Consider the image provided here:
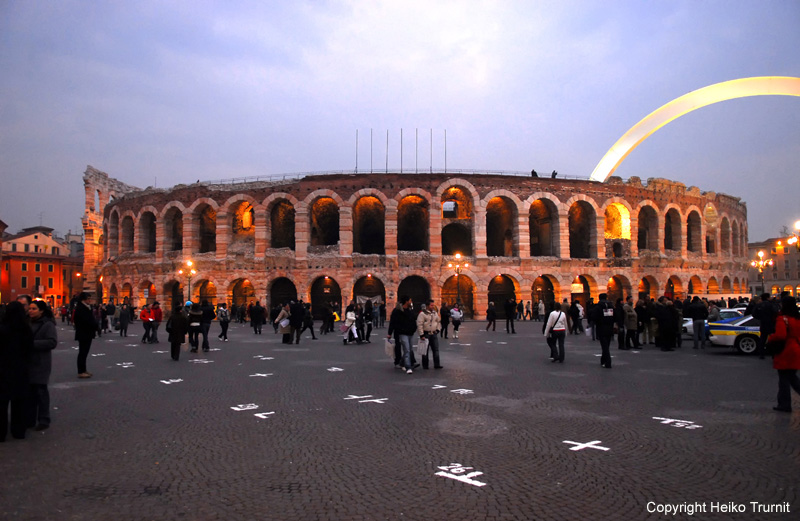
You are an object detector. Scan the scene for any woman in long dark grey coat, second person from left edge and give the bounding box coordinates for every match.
[27,300,58,431]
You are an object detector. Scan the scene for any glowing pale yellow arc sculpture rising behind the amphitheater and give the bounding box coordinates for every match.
[590,76,800,183]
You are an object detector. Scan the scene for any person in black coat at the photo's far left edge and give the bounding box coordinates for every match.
[0,302,33,442]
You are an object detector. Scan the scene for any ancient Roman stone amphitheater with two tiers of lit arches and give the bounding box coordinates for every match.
[83,166,748,317]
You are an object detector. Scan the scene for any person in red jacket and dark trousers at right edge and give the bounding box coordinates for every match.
[767,296,800,412]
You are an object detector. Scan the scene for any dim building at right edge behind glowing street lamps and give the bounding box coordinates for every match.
[747,237,800,297]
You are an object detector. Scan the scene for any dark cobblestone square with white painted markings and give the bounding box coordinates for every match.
[0,322,800,521]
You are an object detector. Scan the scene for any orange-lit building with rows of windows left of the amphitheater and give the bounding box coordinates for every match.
[0,226,83,307]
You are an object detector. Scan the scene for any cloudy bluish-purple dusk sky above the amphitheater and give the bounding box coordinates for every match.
[0,0,800,241]
